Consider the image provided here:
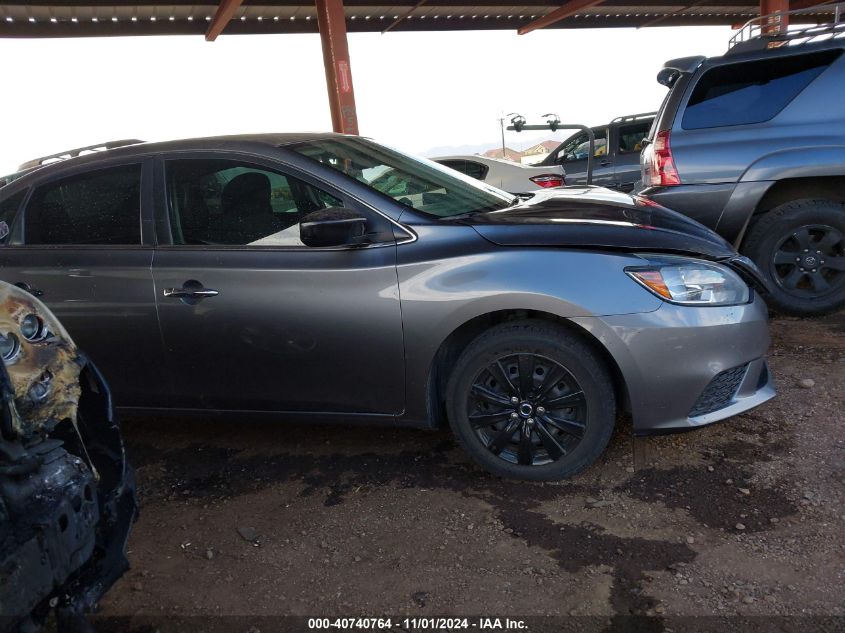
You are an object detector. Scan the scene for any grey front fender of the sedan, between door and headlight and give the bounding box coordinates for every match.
[397,227,661,423]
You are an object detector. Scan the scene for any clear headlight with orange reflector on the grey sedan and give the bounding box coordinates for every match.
[625,255,750,306]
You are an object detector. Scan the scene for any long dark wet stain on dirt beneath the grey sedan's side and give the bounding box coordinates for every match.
[136,442,695,631]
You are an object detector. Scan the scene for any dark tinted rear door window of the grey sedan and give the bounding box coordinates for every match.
[24,165,141,246]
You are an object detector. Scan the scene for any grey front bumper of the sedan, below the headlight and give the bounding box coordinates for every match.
[573,293,775,435]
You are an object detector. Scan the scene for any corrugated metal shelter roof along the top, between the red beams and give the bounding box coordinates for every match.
[0,0,833,37]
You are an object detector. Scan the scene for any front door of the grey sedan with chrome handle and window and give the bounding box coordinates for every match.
[153,153,405,416]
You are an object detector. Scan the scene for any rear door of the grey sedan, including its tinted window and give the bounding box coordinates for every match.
[0,160,167,406]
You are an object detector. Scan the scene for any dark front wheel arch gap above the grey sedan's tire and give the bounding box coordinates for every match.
[426,309,631,427]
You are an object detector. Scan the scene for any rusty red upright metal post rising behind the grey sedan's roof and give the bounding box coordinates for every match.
[316,0,358,134]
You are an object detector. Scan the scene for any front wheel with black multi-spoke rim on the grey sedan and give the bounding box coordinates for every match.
[446,321,616,481]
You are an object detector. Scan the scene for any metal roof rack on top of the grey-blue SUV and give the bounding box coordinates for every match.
[726,2,845,55]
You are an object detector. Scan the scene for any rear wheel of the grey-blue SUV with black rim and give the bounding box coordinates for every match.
[742,200,845,316]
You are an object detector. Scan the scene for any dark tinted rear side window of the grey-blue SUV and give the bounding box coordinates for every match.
[681,50,842,130]
